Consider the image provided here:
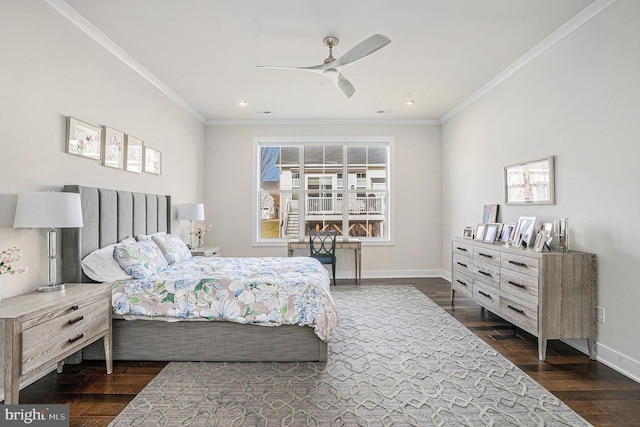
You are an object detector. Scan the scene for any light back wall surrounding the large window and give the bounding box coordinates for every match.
[205,125,442,278]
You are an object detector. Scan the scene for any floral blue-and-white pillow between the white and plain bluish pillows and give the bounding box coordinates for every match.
[113,240,169,279]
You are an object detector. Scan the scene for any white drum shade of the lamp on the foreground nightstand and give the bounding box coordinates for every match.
[13,191,83,228]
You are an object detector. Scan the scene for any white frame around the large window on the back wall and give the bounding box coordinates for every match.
[251,136,395,246]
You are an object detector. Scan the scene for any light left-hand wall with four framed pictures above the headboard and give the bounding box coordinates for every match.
[0,0,205,298]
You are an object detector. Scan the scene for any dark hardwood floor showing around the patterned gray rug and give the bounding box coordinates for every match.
[10,279,640,426]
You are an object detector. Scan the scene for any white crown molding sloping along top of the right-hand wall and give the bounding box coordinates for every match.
[440,0,617,123]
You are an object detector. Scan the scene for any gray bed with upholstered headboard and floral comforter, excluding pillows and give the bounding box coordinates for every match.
[62,185,338,362]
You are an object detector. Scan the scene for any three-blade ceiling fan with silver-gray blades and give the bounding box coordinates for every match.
[257,34,391,98]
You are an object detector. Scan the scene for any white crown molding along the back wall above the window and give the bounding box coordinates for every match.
[206,119,440,126]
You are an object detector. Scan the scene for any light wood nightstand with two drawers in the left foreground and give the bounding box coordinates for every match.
[0,283,113,405]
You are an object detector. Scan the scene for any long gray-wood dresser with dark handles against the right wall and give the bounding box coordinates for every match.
[451,238,596,360]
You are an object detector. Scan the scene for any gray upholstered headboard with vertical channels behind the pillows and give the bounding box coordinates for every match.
[62,185,171,283]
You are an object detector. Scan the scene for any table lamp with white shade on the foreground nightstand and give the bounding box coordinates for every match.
[13,191,83,292]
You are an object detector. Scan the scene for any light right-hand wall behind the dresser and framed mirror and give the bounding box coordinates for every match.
[442,0,640,378]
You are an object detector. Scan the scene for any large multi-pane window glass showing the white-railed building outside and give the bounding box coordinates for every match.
[255,139,390,244]
